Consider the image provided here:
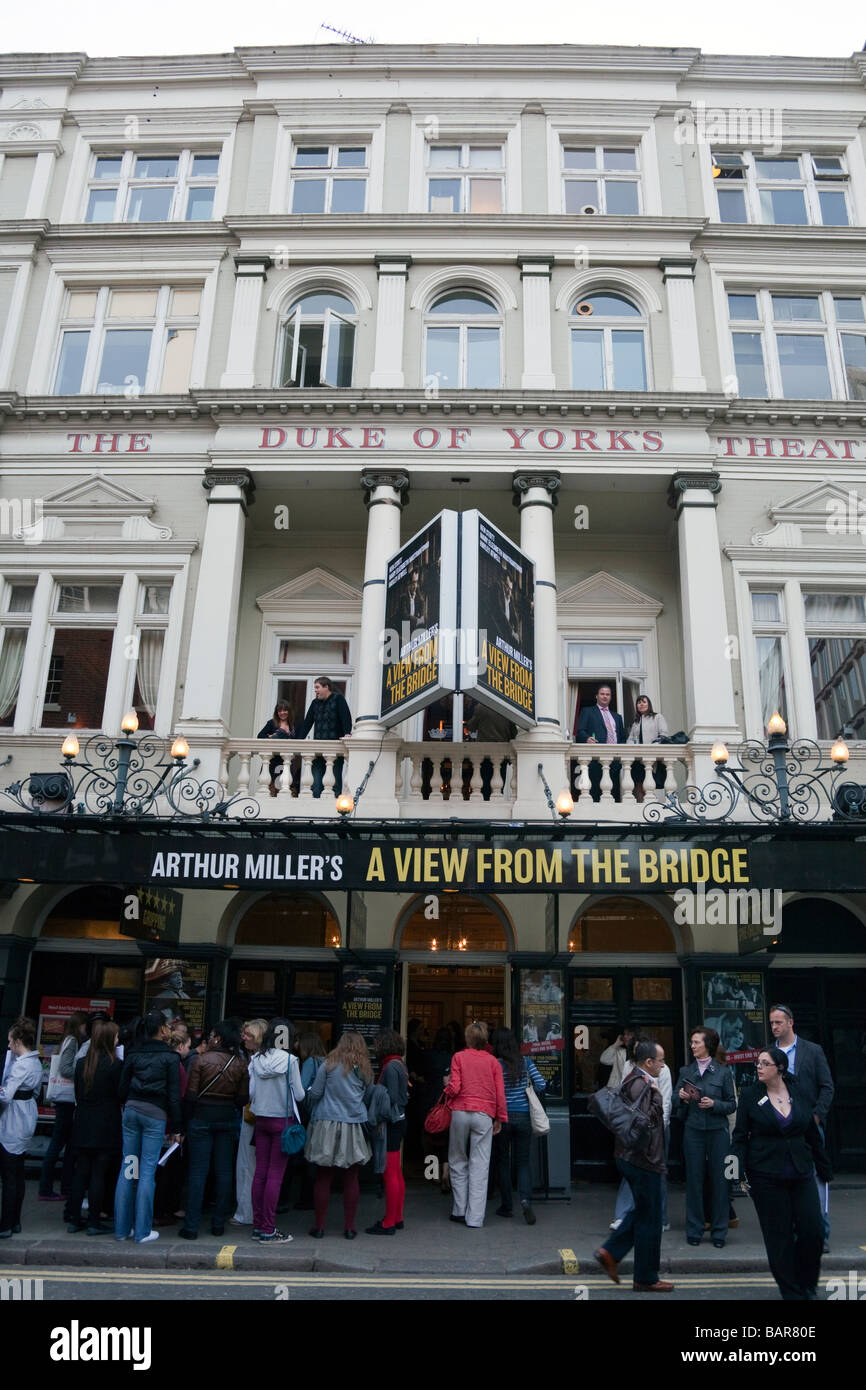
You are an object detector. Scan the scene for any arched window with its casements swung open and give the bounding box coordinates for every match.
[279,291,357,386]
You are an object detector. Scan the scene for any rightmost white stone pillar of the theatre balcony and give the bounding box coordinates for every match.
[669,473,740,742]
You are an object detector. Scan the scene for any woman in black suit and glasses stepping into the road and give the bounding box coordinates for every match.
[734,1047,831,1302]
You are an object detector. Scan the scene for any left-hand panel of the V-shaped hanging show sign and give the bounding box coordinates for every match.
[379,512,457,727]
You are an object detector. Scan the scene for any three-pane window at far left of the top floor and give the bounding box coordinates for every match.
[85,150,220,222]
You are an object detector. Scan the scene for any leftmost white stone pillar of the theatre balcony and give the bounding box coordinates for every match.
[178,468,254,774]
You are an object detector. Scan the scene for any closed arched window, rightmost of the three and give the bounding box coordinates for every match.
[570,291,646,391]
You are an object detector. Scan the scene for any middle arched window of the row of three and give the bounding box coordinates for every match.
[424,289,502,391]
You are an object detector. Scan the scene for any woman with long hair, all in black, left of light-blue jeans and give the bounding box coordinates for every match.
[67,1019,122,1236]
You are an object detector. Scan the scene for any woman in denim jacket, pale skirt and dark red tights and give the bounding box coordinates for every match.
[304,1033,373,1240]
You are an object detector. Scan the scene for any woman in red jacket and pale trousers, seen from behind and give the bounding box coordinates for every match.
[445,1023,509,1227]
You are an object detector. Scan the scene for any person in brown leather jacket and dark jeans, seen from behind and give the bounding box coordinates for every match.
[178,1019,249,1240]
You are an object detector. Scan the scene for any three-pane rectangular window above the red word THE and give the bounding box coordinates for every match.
[53,285,202,396]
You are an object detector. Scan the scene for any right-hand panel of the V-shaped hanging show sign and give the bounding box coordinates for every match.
[460,512,535,728]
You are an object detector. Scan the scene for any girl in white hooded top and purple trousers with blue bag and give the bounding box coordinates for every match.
[249,1019,304,1245]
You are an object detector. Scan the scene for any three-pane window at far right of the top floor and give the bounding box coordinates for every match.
[712,150,851,227]
